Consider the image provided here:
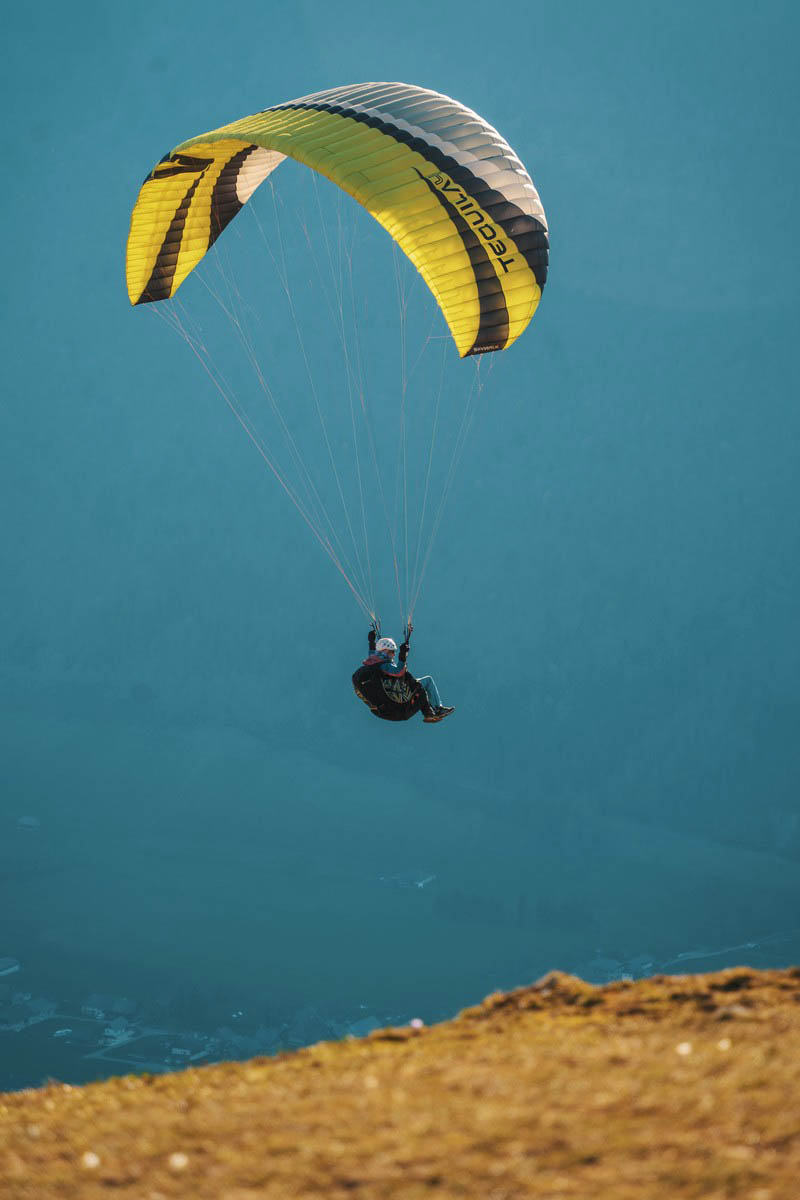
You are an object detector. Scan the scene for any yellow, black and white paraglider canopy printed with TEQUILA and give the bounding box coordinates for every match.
[127,83,548,356]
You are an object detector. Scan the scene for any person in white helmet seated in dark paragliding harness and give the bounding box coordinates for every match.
[353,620,455,725]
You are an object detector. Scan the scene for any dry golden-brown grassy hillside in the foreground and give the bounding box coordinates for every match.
[0,968,800,1200]
